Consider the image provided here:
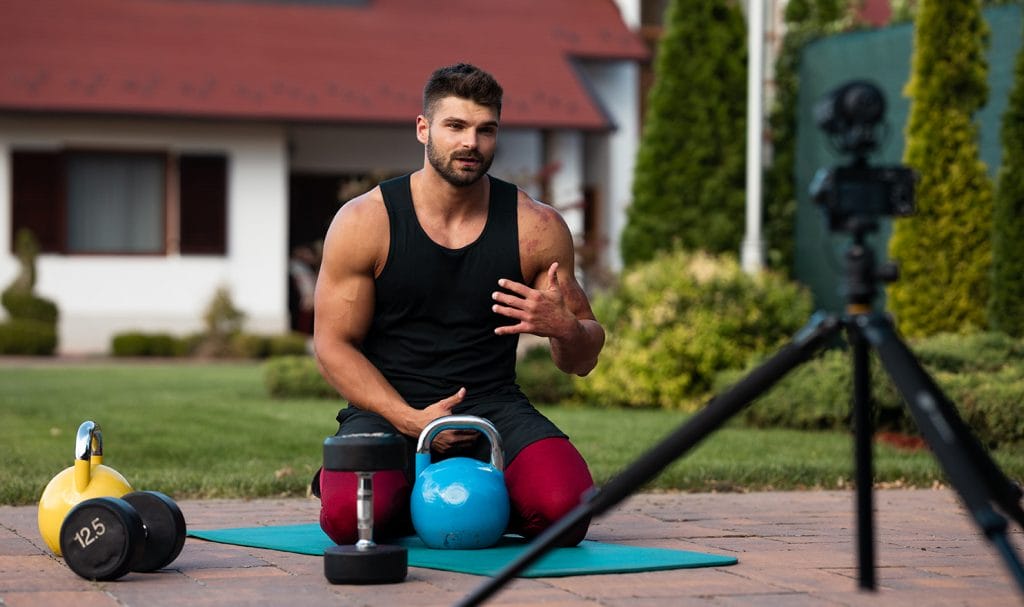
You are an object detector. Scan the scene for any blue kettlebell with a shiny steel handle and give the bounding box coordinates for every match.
[411,416,509,550]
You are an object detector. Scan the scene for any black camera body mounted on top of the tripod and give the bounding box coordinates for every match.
[810,165,915,231]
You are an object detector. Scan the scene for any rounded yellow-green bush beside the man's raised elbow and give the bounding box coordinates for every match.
[574,252,811,410]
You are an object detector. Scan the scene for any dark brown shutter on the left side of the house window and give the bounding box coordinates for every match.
[10,150,66,253]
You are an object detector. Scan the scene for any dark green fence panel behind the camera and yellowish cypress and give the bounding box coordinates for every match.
[794,5,1022,312]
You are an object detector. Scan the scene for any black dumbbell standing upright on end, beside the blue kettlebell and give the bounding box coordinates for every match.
[324,434,409,583]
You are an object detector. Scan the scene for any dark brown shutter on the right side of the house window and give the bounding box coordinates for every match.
[178,155,227,255]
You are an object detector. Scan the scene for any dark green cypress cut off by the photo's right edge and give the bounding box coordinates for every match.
[988,18,1024,337]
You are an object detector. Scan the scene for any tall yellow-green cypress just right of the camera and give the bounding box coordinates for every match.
[888,0,992,337]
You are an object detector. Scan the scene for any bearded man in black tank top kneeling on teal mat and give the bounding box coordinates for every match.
[313,63,604,545]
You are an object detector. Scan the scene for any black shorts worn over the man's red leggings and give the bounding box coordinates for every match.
[312,386,568,494]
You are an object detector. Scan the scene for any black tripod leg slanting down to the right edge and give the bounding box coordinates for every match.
[862,316,1024,592]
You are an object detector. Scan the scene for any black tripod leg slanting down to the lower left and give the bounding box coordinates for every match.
[458,314,842,606]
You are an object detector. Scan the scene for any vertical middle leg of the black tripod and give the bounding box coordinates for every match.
[849,316,876,591]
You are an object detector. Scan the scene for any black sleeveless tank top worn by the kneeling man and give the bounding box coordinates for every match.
[362,175,523,408]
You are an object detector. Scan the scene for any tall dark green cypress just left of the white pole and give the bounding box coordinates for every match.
[622,0,746,265]
